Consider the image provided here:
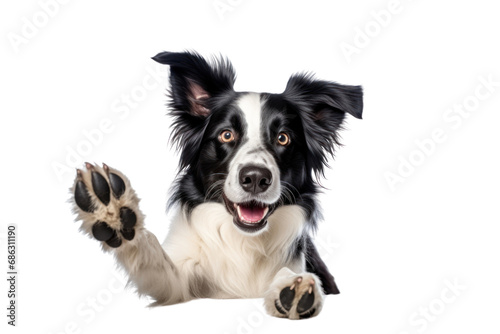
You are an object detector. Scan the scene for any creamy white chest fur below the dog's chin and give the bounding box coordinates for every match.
[163,203,305,298]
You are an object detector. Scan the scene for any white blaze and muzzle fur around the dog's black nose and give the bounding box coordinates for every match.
[224,93,280,204]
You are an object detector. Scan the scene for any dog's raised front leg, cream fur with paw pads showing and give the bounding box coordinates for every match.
[72,163,189,305]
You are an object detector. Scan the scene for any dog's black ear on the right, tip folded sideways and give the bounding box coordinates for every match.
[283,74,363,176]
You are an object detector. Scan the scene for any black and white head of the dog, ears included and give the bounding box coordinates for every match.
[153,52,363,233]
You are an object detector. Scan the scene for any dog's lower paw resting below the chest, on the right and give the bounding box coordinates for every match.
[264,268,324,319]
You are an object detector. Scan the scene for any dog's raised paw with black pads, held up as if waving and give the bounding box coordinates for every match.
[72,163,144,248]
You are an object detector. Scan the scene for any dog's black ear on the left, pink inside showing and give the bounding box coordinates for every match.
[153,52,235,117]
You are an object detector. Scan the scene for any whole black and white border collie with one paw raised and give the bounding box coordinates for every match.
[72,52,363,319]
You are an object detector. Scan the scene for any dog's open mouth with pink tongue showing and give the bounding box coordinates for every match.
[224,195,274,233]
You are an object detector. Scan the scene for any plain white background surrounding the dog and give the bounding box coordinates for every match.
[0,0,500,334]
